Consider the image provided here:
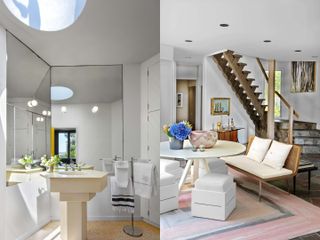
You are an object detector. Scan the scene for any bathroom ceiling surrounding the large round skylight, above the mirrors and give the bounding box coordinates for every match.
[0,0,160,65]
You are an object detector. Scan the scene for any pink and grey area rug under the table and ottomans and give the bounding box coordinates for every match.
[160,171,320,240]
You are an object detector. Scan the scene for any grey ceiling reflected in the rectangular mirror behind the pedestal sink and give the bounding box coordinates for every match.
[51,65,122,104]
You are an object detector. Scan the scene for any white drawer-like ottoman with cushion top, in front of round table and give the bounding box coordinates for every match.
[191,173,236,220]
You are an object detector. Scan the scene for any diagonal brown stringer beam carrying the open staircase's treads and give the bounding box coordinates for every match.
[223,51,264,117]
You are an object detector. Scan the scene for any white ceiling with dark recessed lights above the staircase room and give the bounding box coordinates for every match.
[160,0,320,62]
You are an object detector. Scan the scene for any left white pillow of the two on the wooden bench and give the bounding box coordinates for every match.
[247,137,272,162]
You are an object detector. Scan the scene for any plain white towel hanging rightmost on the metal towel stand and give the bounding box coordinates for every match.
[133,162,158,199]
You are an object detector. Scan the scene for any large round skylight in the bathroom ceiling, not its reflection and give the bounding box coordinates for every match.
[3,0,86,31]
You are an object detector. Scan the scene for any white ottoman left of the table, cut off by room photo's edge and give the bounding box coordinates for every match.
[160,159,183,213]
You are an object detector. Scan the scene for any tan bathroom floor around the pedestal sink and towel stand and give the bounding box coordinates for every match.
[28,221,160,240]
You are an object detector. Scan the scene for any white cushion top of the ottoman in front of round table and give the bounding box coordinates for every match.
[194,173,233,192]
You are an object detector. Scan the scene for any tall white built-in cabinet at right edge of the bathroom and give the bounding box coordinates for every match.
[141,55,160,225]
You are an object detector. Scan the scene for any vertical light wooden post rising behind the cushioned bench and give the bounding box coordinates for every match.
[267,60,276,139]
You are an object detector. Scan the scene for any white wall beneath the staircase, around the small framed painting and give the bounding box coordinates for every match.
[202,57,255,143]
